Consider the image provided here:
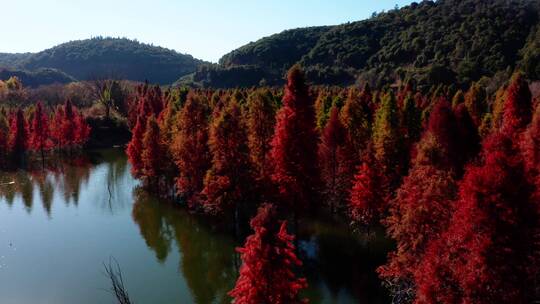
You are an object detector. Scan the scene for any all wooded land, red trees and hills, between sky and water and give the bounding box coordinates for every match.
[0,0,540,304]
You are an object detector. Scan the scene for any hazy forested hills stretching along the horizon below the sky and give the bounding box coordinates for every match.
[0,0,540,88]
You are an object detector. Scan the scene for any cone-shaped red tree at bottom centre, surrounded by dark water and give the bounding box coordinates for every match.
[229,204,307,304]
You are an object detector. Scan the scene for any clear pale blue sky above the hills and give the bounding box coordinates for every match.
[0,0,412,62]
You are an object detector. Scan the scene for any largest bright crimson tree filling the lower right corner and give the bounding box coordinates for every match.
[415,132,539,304]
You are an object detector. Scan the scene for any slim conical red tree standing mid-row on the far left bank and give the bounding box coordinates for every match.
[29,102,52,163]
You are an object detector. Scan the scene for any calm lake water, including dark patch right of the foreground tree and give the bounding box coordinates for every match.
[0,150,388,304]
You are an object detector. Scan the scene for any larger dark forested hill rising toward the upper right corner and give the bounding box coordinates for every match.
[187,0,540,87]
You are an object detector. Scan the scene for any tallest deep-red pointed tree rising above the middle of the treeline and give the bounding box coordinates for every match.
[270,66,319,215]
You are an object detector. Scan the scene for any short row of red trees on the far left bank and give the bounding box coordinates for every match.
[0,99,90,169]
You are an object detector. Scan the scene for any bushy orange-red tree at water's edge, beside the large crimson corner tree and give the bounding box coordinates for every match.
[379,164,457,283]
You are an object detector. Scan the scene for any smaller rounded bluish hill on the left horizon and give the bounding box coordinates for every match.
[0,37,204,84]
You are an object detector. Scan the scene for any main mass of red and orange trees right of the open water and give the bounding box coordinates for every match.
[127,67,540,303]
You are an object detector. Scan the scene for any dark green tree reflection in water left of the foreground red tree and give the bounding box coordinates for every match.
[133,189,238,304]
